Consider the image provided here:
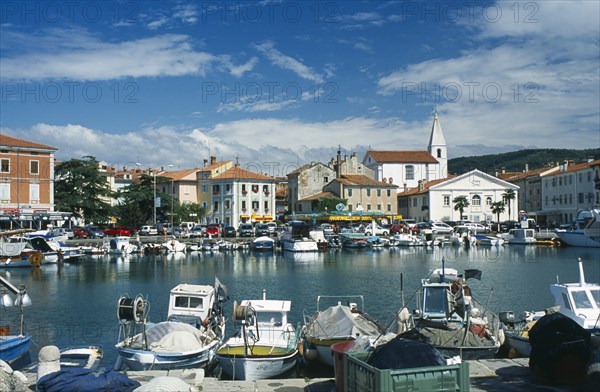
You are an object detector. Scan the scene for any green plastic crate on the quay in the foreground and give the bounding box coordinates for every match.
[344,352,471,392]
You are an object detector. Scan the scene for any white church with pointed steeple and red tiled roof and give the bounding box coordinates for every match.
[363,113,448,192]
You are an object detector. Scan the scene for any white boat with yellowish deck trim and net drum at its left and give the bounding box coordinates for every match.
[216,290,298,380]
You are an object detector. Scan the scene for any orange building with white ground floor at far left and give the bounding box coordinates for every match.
[0,134,58,226]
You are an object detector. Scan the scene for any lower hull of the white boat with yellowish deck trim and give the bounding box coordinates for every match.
[217,350,298,381]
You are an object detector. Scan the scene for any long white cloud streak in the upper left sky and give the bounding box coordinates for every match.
[0,31,217,80]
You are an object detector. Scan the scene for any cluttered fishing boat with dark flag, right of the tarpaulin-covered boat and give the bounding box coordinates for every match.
[412,267,504,360]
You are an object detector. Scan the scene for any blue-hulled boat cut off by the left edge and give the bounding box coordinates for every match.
[0,276,31,365]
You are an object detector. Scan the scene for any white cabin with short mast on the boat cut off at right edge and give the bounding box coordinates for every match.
[550,262,600,331]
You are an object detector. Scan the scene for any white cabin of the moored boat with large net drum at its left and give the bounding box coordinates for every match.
[168,283,216,324]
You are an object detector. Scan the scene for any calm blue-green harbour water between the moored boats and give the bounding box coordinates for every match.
[0,245,600,372]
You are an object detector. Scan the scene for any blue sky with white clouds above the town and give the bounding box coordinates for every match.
[0,0,600,175]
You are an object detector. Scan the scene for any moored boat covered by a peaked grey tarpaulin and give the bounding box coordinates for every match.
[302,295,385,366]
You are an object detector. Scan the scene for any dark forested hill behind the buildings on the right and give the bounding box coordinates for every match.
[448,148,600,175]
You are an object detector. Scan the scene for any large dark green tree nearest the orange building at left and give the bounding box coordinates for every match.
[54,156,113,223]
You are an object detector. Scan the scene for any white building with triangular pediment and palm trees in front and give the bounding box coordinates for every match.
[398,170,519,222]
